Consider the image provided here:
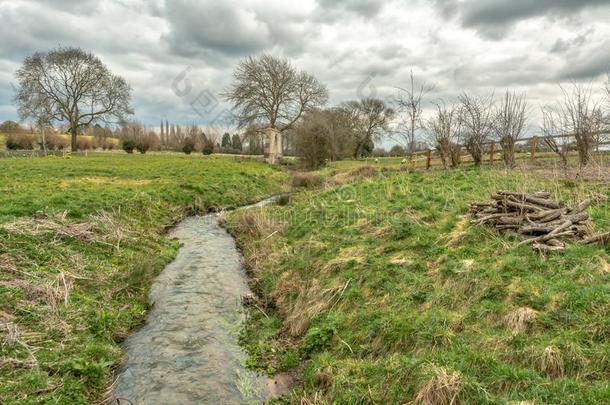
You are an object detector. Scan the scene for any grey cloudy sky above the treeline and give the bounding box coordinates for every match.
[0,0,610,133]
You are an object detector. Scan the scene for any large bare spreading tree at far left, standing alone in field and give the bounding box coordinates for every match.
[15,47,132,150]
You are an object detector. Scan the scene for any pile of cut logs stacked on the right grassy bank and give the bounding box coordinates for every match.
[470,190,610,252]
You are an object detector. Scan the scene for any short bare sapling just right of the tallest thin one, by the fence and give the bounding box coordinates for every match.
[426,102,460,169]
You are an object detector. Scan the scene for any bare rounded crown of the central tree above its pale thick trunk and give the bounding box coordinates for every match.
[224,55,328,132]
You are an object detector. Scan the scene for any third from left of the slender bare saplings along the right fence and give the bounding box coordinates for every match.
[459,93,494,166]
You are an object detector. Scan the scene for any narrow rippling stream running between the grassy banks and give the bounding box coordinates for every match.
[113,199,274,404]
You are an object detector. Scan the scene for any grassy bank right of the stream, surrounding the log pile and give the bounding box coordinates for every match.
[227,169,610,404]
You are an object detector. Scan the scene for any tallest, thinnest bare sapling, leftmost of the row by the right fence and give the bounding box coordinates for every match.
[395,71,432,159]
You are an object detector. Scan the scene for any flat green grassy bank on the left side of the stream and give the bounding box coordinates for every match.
[0,155,285,403]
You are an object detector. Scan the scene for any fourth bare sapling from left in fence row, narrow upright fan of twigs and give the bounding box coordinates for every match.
[492,91,528,167]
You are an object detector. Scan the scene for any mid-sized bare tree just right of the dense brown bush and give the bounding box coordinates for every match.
[339,98,394,159]
